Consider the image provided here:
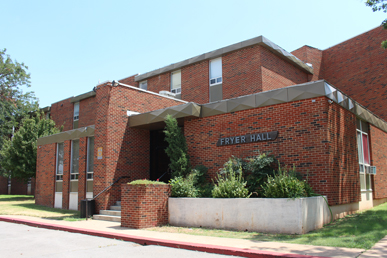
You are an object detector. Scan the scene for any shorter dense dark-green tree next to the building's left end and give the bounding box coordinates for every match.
[0,113,59,181]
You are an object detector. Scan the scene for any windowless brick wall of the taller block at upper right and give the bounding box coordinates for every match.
[321,27,387,120]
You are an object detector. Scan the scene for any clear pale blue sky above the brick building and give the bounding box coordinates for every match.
[0,0,386,107]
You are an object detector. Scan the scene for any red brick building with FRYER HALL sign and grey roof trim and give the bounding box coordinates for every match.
[36,27,387,218]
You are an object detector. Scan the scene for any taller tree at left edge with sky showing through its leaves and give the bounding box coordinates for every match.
[0,49,38,175]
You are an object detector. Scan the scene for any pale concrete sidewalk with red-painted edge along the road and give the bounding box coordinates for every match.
[0,215,376,258]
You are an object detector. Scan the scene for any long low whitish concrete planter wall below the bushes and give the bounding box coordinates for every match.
[168,196,330,234]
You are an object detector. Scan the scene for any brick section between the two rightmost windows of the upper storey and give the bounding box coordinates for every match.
[181,60,210,104]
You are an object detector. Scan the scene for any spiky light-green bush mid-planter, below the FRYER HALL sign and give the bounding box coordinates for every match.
[212,159,251,198]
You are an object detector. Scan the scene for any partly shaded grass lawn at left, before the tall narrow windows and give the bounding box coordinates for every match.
[0,195,82,221]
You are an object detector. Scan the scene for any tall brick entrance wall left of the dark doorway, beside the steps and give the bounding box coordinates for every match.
[94,84,182,211]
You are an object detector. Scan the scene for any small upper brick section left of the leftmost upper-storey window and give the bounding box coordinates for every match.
[50,98,74,131]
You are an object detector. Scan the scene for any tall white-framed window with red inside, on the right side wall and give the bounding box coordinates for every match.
[356,120,372,190]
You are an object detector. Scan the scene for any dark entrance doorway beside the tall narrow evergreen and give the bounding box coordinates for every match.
[150,130,171,183]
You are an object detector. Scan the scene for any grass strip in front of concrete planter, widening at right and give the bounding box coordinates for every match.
[148,203,387,249]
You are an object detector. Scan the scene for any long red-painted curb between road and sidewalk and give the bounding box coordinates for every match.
[0,217,328,258]
